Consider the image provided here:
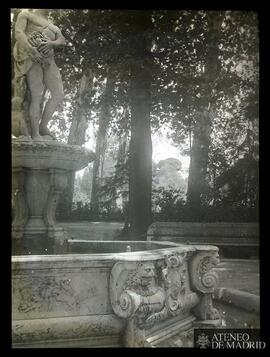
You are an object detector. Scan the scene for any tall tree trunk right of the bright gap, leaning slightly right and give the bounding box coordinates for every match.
[187,12,223,210]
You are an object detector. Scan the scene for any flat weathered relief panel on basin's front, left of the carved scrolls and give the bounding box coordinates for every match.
[12,256,115,320]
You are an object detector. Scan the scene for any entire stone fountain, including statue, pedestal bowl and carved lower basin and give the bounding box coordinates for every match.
[12,9,220,348]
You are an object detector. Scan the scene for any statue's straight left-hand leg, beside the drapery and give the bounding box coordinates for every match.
[26,63,44,140]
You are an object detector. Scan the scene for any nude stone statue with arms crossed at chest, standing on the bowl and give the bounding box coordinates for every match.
[13,9,66,140]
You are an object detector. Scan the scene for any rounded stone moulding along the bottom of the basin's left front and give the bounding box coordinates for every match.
[12,314,124,347]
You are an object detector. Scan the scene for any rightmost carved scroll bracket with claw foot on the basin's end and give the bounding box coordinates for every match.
[189,247,221,326]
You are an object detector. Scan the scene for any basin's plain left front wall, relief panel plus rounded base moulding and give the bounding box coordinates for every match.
[12,256,123,347]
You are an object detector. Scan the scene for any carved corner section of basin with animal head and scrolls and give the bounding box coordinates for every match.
[110,242,220,347]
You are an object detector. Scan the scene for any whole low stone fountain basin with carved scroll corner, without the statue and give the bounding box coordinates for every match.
[12,241,220,348]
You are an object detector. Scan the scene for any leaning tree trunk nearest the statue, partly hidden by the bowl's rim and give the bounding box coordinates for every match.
[58,69,94,217]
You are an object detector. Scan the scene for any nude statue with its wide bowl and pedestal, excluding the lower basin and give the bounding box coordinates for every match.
[12,9,94,254]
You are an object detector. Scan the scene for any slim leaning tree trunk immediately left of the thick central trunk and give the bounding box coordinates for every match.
[91,71,114,218]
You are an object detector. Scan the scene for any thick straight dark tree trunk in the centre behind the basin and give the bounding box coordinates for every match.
[129,11,152,240]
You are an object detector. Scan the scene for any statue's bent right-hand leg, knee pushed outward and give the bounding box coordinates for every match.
[39,61,64,136]
